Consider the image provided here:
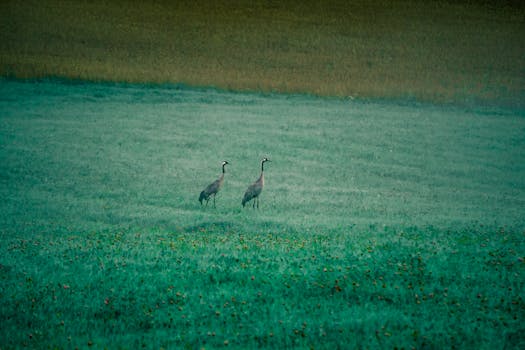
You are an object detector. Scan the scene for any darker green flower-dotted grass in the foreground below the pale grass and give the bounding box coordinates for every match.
[1,226,525,349]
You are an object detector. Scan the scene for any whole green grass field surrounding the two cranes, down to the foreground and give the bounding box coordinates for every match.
[0,80,525,349]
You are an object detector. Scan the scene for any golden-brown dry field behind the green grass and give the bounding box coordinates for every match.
[0,0,525,106]
